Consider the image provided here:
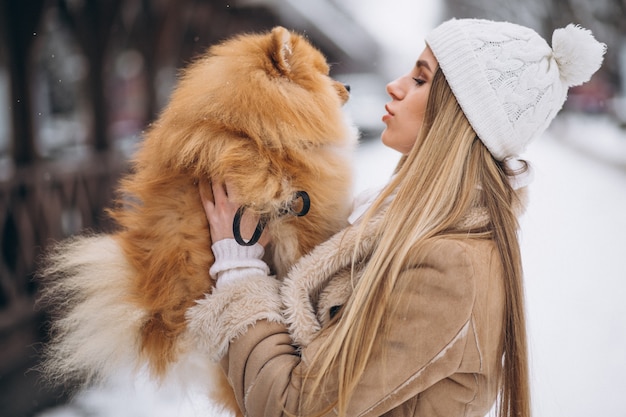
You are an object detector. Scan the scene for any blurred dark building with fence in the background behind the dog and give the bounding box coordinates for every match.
[0,0,380,417]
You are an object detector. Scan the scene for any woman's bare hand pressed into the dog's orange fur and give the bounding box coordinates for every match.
[199,182,270,247]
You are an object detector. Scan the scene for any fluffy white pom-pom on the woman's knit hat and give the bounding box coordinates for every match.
[552,23,606,87]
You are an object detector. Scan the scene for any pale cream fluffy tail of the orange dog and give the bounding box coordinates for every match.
[38,235,147,385]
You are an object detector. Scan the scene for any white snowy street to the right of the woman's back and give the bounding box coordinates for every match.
[521,119,626,417]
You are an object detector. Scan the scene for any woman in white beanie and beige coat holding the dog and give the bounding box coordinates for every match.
[188,19,605,417]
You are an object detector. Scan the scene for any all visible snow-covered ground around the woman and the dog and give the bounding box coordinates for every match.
[39,115,626,417]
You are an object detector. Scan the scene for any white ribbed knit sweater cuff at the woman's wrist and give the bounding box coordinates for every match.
[209,239,270,288]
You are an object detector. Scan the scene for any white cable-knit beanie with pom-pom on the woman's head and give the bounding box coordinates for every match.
[426,19,606,161]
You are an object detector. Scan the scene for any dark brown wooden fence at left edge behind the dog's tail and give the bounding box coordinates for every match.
[0,153,127,416]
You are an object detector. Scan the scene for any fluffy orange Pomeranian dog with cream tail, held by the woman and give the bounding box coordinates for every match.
[40,27,357,410]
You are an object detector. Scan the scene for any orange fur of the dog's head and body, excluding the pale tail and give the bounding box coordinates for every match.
[105,27,355,412]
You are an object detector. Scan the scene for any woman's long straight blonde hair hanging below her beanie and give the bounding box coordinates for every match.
[301,70,530,417]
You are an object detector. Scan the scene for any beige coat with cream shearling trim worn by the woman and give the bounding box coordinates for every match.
[188,206,504,417]
